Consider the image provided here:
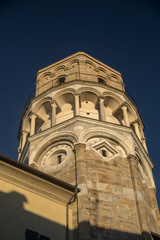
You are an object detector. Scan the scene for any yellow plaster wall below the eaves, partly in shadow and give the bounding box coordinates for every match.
[0,175,72,240]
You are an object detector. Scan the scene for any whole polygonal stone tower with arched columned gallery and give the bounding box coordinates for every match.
[18,52,160,240]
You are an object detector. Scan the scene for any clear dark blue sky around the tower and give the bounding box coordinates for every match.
[0,0,160,205]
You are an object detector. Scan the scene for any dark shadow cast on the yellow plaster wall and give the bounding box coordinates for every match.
[0,192,70,240]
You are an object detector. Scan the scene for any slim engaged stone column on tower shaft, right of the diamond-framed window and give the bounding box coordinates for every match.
[128,154,151,240]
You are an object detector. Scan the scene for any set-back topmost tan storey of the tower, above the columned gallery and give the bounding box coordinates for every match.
[36,52,124,96]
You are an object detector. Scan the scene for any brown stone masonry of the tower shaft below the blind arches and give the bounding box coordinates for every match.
[48,144,158,240]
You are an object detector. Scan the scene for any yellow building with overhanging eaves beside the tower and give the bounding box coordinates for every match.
[0,155,77,240]
